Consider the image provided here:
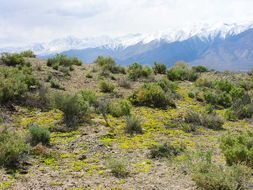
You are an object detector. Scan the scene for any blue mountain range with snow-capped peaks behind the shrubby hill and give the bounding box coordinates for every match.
[0,23,253,71]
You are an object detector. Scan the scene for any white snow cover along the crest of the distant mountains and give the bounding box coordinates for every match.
[0,22,253,55]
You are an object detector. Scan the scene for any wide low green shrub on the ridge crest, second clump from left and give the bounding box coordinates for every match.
[47,54,82,70]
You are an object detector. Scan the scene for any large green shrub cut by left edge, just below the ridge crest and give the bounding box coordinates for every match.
[0,67,39,104]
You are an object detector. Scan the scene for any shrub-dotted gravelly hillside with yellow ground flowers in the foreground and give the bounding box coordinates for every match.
[0,52,253,190]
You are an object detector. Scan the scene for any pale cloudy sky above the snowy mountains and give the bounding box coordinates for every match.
[0,0,253,47]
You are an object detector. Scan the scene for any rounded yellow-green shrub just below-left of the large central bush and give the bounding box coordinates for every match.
[109,100,131,117]
